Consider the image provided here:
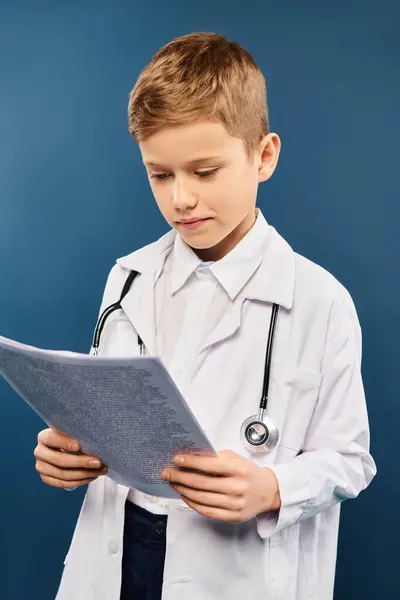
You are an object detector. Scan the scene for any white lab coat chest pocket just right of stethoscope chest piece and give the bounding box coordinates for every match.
[268,363,322,460]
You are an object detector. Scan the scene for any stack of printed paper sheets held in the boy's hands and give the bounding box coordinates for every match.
[0,336,216,498]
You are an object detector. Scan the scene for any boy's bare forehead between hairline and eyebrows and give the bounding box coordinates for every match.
[139,122,242,167]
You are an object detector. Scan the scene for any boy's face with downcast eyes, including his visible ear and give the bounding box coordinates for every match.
[139,121,280,261]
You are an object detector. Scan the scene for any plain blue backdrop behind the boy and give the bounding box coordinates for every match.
[0,0,400,600]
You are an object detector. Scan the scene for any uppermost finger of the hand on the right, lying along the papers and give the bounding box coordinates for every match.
[174,454,247,476]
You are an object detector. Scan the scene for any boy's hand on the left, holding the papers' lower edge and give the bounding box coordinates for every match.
[34,429,108,489]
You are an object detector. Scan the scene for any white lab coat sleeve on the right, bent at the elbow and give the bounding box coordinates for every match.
[256,286,376,539]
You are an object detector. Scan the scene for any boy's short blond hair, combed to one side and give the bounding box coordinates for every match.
[128,33,269,158]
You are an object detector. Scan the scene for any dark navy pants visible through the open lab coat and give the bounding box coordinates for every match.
[120,500,167,600]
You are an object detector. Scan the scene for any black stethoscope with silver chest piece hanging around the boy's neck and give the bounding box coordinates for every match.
[92,271,279,454]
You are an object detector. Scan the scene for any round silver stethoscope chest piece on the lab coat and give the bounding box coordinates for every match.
[240,415,279,454]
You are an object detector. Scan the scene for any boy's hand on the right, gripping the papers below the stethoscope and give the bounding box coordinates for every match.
[162,450,281,523]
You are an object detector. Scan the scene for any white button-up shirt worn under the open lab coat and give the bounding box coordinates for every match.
[128,208,268,514]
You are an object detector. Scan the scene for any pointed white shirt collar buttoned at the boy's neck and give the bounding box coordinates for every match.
[171,208,269,301]
